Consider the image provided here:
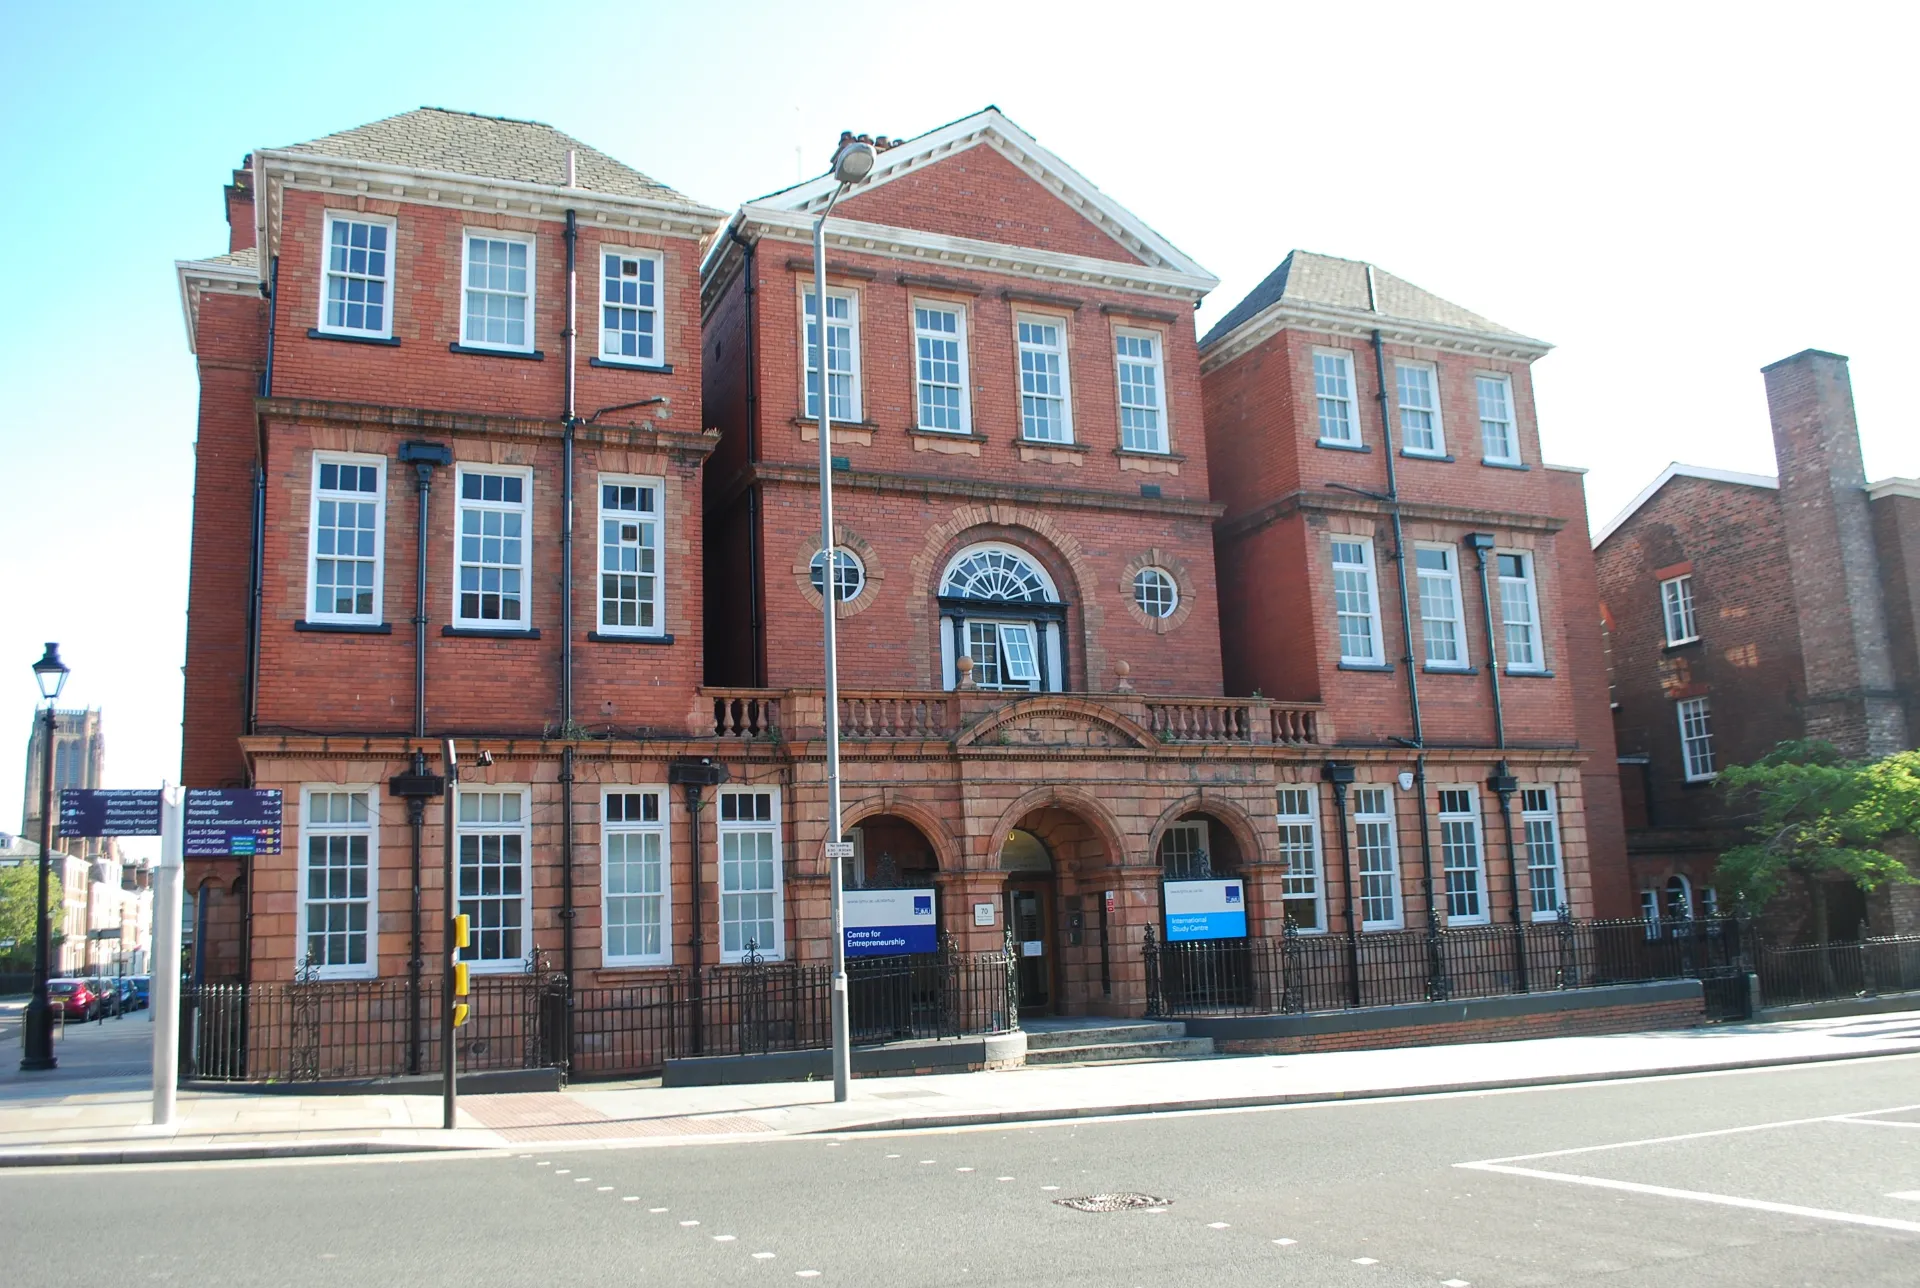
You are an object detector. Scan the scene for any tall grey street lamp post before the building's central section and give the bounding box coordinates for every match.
[814,134,876,1102]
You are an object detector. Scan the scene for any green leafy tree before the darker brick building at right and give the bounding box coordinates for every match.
[1718,739,1920,944]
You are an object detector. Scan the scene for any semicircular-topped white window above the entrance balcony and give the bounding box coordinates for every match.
[939,541,1068,693]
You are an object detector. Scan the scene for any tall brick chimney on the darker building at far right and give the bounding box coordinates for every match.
[1761,349,1907,756]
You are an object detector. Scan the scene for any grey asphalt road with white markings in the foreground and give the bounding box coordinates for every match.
[0,1058,1920,1288]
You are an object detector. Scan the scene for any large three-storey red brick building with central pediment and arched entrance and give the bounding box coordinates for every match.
[180,109,1617,1044]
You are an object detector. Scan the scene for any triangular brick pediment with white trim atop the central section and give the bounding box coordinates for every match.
[753,107,1215,284]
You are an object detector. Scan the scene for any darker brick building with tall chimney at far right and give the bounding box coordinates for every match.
[1596,349,1920,939]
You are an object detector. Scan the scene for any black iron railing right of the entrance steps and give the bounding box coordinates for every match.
[1144,918,1745,1015]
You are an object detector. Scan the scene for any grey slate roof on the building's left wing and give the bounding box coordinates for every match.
[280,107,697,205]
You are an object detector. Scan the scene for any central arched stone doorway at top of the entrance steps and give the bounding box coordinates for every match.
[998,802,1117,1015]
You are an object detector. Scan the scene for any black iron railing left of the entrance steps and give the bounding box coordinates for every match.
[180,944,1020,1083]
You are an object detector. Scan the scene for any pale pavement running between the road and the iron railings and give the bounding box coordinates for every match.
[11,1012,1920,1165]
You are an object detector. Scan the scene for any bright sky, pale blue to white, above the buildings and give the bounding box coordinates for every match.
[0,0,1920,856]
